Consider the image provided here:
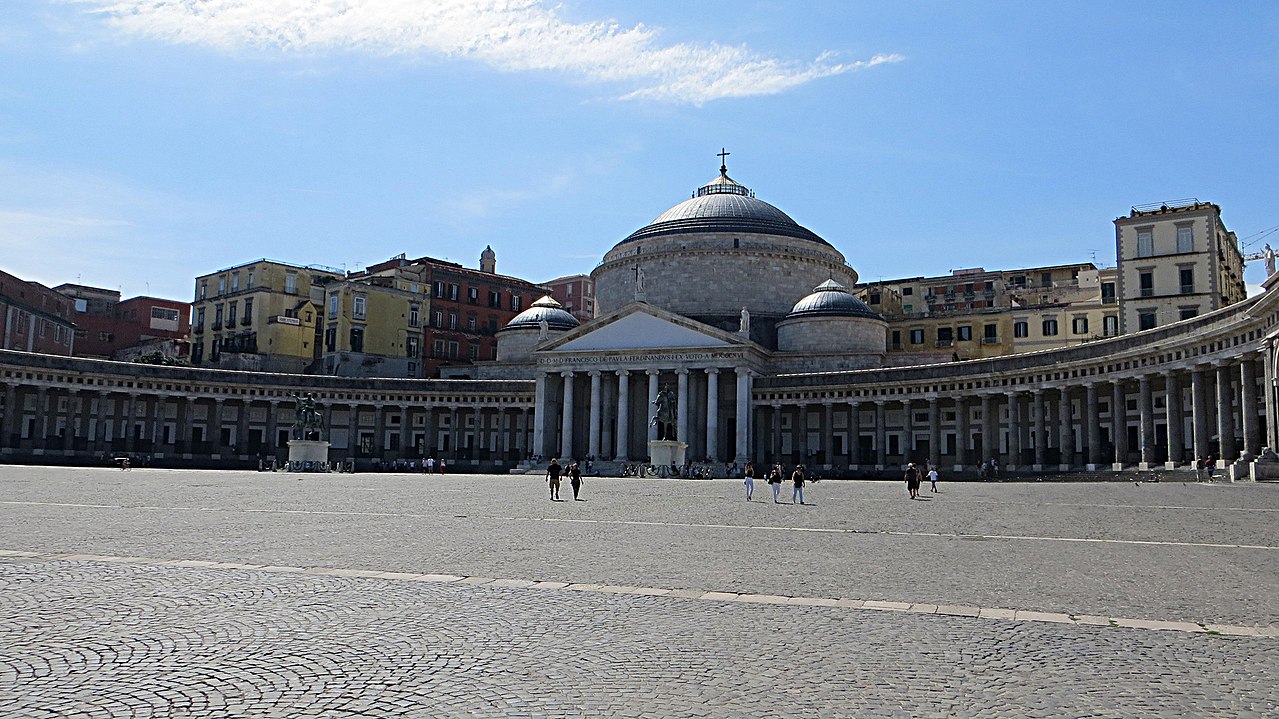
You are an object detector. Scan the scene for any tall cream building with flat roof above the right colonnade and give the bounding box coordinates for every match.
[1115,200,1247,333]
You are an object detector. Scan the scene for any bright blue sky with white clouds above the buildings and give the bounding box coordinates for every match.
[0,0,1279,301]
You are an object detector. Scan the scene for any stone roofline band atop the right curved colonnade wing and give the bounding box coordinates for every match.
[755,293,1279,391]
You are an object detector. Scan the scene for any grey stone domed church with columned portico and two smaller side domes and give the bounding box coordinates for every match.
[473,152,885,462]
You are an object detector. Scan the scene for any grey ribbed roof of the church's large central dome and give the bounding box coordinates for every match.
[618,166,828,246]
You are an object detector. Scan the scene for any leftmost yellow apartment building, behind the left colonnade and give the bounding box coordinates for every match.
[191,260,343,372]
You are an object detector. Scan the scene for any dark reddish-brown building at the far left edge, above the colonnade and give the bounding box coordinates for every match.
[0,271,75,354]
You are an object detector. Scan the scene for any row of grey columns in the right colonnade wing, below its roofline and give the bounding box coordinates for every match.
[756,352,1275,470]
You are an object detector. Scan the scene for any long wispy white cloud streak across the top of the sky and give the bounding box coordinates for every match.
[70,0,902,104]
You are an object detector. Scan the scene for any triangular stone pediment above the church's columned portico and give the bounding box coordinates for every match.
[544,306,746,352]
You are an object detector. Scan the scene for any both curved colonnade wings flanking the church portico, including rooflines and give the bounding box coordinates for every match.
[0,278,1279,471]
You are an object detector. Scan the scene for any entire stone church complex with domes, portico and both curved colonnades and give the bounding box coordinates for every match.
[0,166,1279,471]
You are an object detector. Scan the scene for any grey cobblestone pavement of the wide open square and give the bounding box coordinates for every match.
[0,467,1279,718]
